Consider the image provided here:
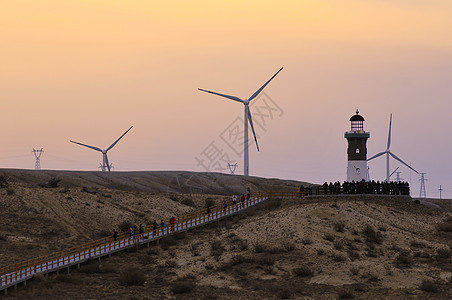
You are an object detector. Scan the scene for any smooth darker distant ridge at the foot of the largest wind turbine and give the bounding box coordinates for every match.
[0,169,306,195]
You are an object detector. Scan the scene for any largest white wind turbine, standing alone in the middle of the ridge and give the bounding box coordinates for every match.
[198,68,283,176]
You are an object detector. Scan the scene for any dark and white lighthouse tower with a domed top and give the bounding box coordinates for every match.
[345,110,370,181]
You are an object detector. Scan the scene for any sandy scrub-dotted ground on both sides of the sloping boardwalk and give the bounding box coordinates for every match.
[0,170,452,299]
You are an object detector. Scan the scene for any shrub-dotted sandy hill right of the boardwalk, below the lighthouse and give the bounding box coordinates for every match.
[5,196,452,299]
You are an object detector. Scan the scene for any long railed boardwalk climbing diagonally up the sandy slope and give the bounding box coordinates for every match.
[0,192,297,294]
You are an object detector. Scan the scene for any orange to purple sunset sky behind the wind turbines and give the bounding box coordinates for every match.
[0,0,452,198]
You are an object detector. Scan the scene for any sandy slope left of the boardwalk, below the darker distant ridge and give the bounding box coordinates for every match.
[0,183,231,266]
